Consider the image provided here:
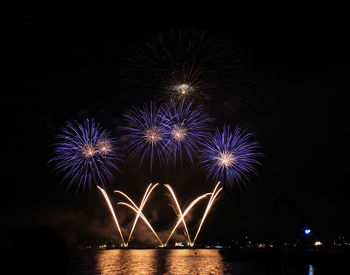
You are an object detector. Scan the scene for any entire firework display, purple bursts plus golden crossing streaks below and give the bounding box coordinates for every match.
[50,30,262,247]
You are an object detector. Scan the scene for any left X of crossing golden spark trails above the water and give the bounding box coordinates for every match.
[114,183,163,245]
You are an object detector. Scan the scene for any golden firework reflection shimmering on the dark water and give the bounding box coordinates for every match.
[96,249,224,275]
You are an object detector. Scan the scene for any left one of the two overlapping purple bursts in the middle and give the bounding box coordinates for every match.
[123,102,167,170]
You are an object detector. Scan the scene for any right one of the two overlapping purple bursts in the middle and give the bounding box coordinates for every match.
[164,100,209,164]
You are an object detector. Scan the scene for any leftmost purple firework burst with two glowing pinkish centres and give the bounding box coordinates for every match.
[50,119,119,191]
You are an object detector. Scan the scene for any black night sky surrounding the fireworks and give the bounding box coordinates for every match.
[1,10,350,248]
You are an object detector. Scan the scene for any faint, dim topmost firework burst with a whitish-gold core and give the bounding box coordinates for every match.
[122,29,249,104]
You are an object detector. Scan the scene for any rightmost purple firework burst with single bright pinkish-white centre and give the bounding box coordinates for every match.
[200,126,262,189]
